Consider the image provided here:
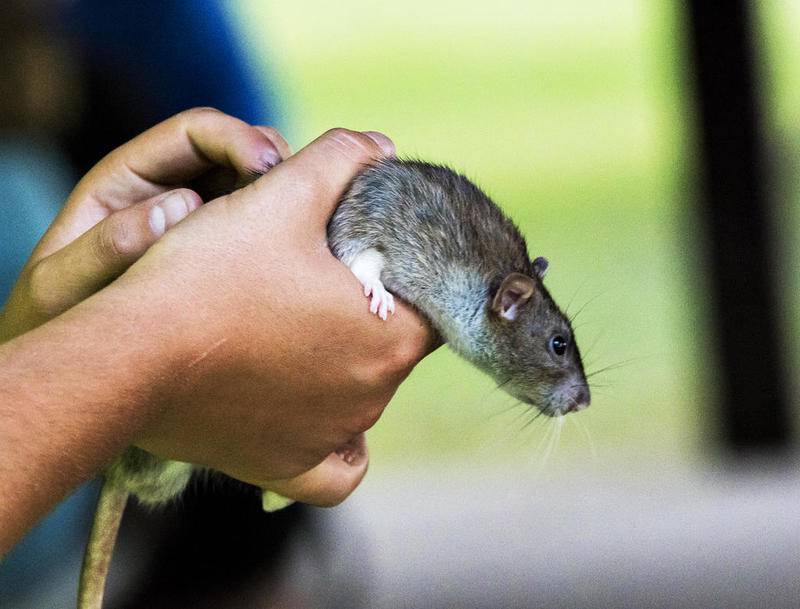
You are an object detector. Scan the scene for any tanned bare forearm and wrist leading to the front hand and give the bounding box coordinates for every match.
[0,291,173,556]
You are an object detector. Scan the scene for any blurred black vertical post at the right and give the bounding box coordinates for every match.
[689,0,791,452]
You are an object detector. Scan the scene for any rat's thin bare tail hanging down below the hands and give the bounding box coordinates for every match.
[78,479,129,609]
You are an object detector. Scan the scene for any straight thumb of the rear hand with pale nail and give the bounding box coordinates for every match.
[30,189,202,317]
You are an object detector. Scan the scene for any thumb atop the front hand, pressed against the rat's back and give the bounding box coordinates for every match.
[244,129,394,224]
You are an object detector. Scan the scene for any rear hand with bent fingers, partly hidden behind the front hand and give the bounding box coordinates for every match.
[0,108,290,342]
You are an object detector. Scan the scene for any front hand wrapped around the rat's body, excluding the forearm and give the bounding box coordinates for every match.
[94,129,433,496]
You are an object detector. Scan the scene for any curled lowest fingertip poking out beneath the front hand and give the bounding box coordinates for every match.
[263,434,369,507]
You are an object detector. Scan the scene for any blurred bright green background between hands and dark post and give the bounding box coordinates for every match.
[231,0,707,467]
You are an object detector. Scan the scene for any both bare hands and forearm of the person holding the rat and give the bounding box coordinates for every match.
[0,110,432,552]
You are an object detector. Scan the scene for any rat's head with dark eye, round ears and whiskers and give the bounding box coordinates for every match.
[487,258,591,416]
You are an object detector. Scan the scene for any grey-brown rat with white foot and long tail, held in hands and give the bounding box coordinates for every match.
[78,159,591,609]
